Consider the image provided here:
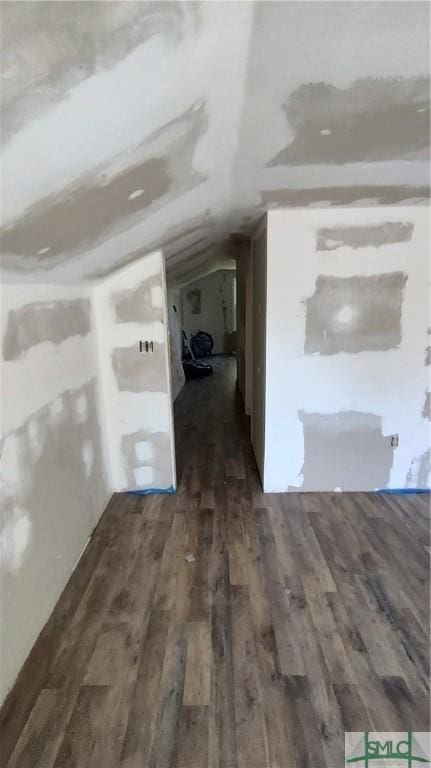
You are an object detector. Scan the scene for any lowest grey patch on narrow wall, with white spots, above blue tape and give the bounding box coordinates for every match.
[121,431,172,488]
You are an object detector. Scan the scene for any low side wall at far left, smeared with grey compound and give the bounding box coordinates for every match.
[0,285,111,699]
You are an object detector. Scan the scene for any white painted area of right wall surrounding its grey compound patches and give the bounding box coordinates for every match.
[265,206,430,491]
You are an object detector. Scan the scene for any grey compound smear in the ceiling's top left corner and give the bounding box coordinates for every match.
[1,0,201,141]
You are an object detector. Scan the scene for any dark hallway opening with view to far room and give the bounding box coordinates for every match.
[167,259,241,494]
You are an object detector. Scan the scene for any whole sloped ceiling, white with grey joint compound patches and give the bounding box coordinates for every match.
[1,0,429,282]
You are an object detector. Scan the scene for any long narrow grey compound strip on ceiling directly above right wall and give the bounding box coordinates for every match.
[259,185,430,208]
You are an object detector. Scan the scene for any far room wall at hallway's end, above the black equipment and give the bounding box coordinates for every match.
[181,269,236,354]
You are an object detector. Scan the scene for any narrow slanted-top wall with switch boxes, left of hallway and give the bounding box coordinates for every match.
[94,252,175,491]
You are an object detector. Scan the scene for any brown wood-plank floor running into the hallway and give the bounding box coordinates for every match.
[2,359,429,768]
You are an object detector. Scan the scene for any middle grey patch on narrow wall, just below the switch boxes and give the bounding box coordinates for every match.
[111,348,167,392]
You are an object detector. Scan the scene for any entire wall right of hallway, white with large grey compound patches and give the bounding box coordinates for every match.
[264,207,430,491]
